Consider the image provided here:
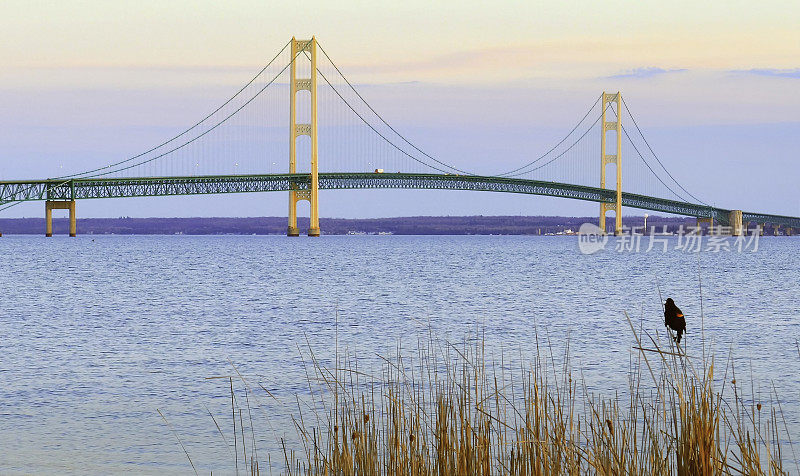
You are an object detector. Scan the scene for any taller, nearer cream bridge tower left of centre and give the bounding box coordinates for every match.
[286,37,319,236]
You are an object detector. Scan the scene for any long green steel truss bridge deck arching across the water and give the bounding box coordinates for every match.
[0,172,800,227]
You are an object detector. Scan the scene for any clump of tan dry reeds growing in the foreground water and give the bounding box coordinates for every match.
[262,322,796,476]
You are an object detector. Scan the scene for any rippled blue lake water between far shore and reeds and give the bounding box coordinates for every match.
[0,236,800,474]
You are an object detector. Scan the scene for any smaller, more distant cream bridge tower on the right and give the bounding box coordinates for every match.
[600,91,622,235]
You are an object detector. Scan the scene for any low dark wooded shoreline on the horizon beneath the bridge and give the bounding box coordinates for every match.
[0,216,696,235]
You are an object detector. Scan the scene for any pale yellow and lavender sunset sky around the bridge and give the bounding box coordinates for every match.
[0,0,800,217]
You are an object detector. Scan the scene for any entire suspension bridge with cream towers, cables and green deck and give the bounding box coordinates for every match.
[0,38,800,236]
